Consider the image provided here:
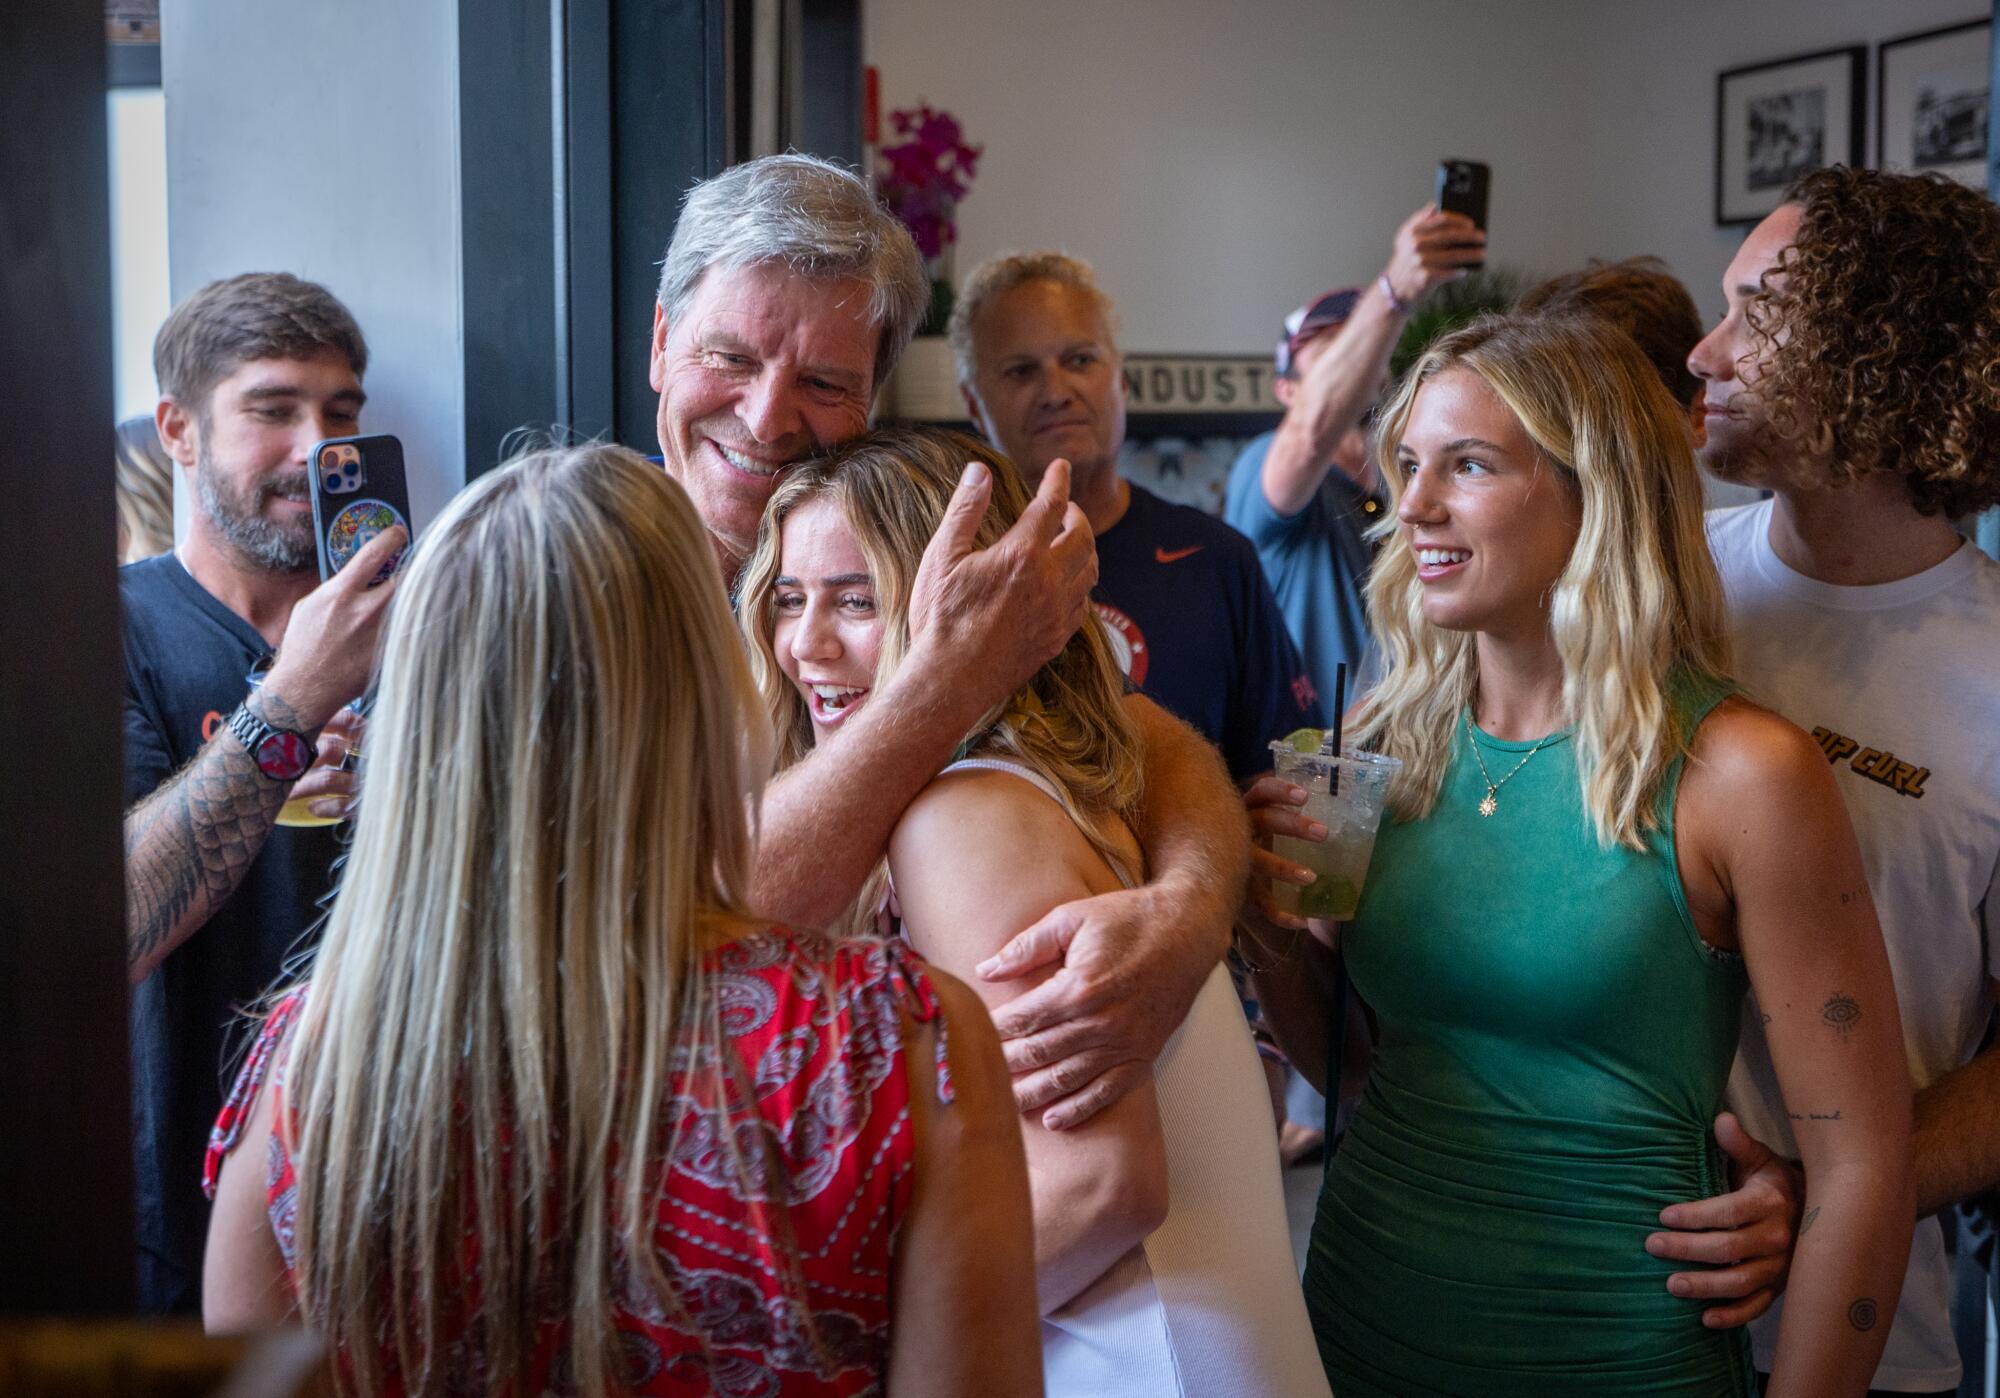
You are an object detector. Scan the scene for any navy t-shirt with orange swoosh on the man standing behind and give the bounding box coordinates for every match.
[1094,486,1326,780]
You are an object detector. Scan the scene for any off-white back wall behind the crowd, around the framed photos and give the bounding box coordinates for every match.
[864,0,1986,352]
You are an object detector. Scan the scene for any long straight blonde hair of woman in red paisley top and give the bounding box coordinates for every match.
[280,446,770,1394]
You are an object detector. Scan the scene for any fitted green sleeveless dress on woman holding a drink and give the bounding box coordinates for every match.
[1306,684,1756,1398]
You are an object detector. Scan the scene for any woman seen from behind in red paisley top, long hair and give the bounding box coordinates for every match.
[204,446,1040,1398]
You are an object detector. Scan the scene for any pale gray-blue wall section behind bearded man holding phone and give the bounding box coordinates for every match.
[160,0,466,524]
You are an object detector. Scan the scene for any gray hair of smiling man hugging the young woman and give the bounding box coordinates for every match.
[660,154,930,388]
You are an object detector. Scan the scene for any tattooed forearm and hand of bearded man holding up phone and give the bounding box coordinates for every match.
[124,530,408,986]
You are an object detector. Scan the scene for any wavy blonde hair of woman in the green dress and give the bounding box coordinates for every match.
[1352,316,1730,848]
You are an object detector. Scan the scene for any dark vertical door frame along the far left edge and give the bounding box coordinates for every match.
[0,0,136,1316]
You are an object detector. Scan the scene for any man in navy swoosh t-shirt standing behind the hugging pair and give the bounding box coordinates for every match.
[950,252,1324,782]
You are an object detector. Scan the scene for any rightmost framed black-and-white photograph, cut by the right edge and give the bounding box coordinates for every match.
[1876,20,1994,190]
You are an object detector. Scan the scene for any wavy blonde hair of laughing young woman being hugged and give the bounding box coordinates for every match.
[736,428,1144,936]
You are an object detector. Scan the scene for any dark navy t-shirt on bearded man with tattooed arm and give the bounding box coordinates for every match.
[118,554,344,1314]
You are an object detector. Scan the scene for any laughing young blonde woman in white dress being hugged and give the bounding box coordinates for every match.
[738,430,1326,1398]
